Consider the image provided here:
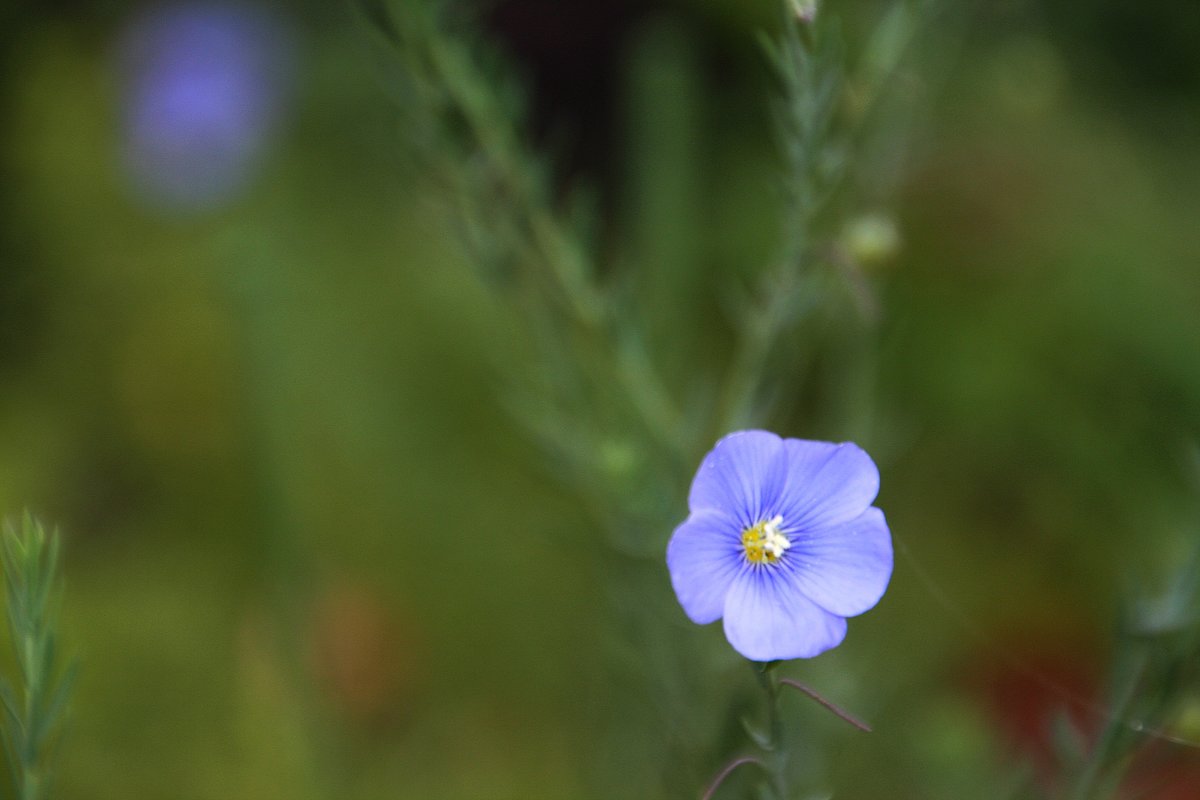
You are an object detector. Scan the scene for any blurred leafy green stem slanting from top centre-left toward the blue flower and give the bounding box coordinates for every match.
[364,2,703,532]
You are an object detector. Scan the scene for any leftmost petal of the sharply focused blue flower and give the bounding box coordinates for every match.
[667,511,744,625]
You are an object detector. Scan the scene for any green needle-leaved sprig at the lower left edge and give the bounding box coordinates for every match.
[0,512,76,800]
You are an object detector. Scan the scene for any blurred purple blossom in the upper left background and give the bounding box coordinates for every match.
[119,2,292,210]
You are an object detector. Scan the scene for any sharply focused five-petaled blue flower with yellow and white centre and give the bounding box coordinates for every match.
[667,431,892,661]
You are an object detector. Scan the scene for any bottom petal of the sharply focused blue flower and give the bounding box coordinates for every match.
[725,567,846,661]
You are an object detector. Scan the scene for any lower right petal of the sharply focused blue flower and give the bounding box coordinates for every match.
[785,507,893,616]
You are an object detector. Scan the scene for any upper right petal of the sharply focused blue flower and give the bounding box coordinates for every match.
[779,439,880,530]
